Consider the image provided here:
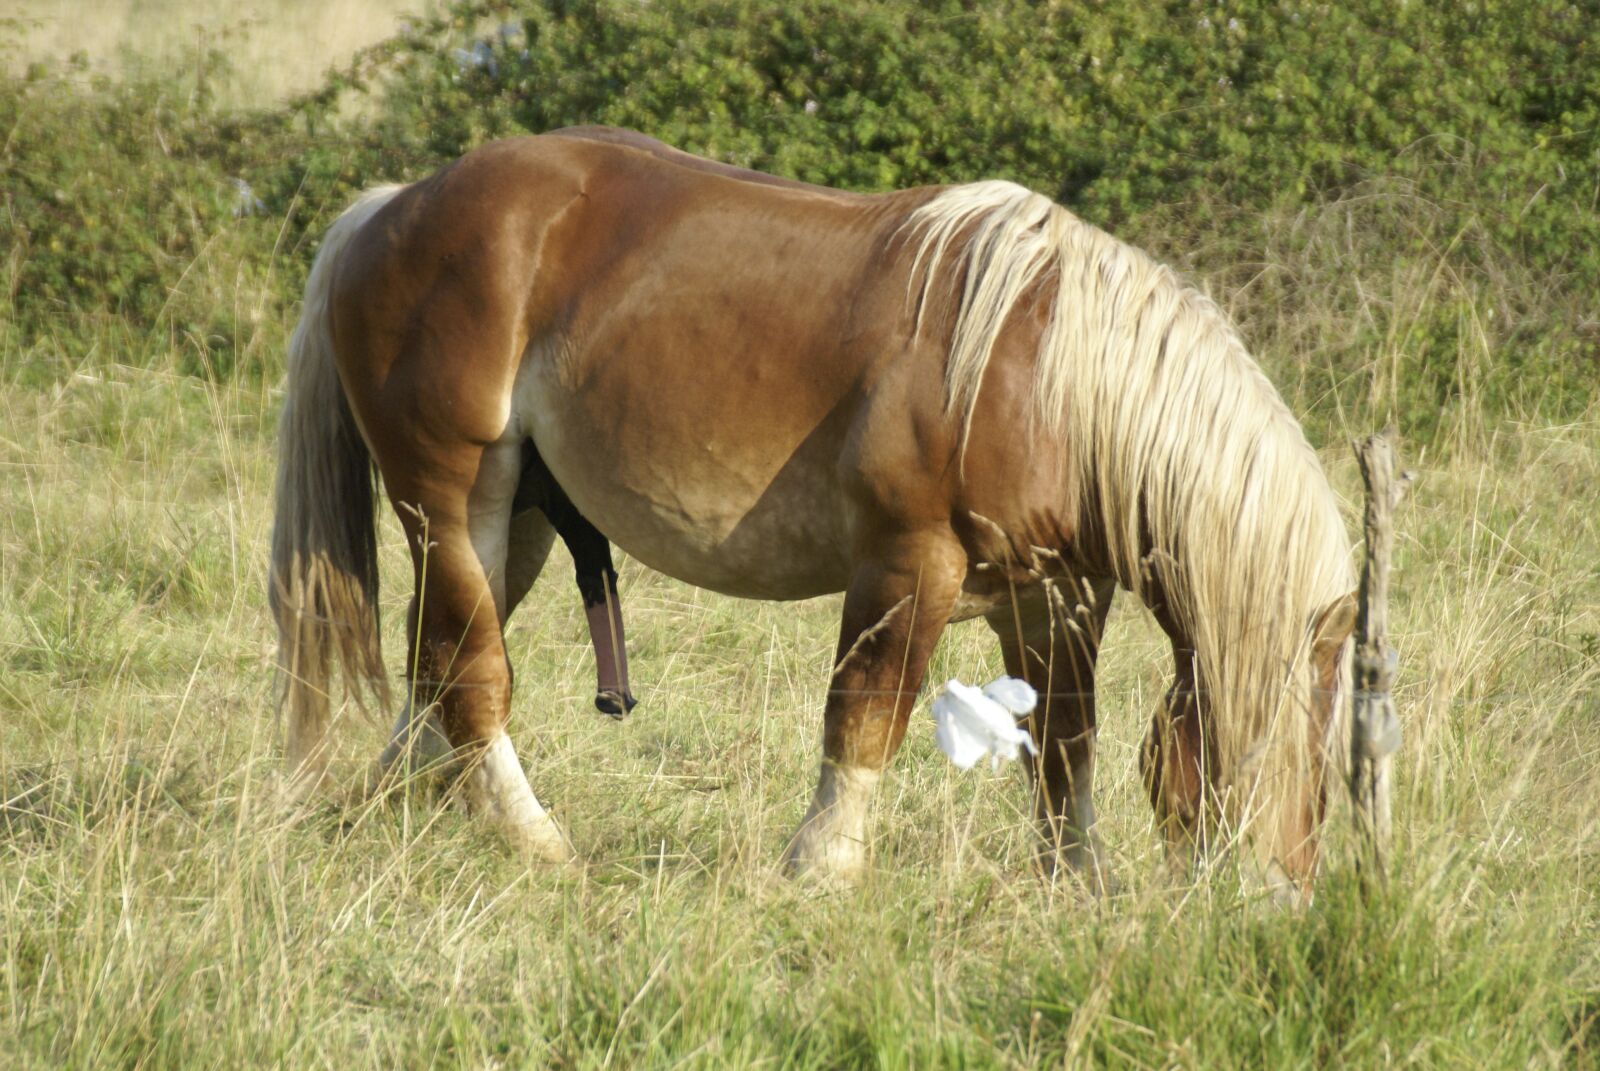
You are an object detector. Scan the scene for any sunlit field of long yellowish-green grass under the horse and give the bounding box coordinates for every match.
[0,5,1600,1068]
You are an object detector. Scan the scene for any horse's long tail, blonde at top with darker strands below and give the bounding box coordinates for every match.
[267,186,402,792]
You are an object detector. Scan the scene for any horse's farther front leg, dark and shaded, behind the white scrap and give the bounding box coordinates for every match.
[986,581,1115,893]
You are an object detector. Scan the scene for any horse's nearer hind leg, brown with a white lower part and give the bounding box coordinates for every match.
[384,443,571,861]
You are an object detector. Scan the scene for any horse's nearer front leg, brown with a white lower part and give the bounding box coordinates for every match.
[786,530,966,879]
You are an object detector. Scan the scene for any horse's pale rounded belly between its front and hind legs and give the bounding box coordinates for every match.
[517,365,850,599]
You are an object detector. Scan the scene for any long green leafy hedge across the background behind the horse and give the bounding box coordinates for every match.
[0,0,1600,432]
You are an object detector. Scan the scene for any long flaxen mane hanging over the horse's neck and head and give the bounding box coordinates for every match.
[904,181,1355,845]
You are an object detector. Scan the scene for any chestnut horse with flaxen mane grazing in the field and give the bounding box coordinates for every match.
[270,128,1354,887]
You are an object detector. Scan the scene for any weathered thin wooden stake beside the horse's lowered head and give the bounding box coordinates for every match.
[1350,429,1411,876]
